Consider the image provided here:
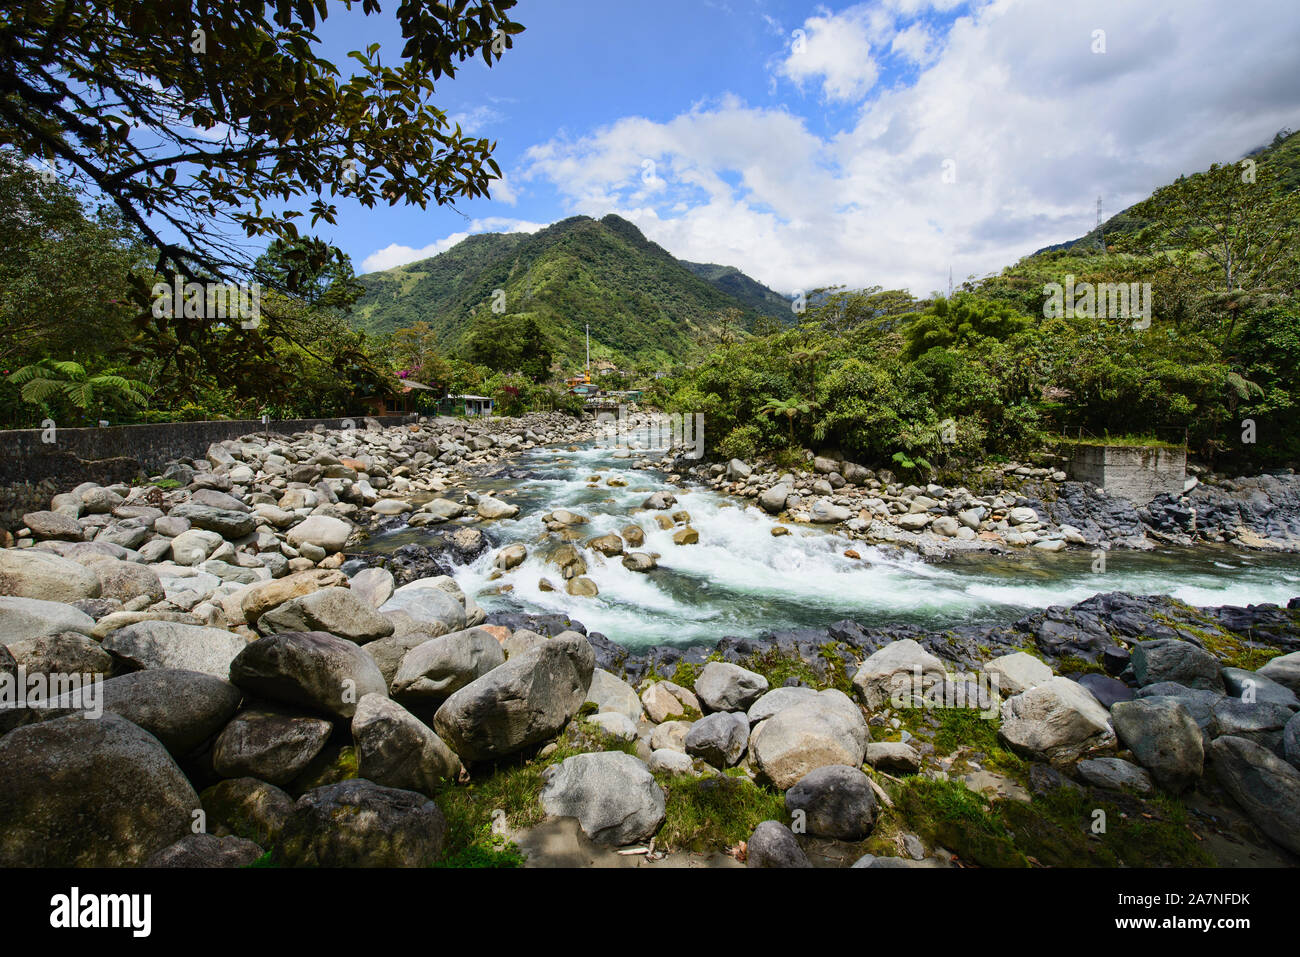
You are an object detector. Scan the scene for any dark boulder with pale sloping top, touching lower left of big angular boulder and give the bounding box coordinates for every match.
[352,694,460,794]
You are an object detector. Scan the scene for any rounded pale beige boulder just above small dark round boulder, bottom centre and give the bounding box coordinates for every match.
[749,689,871,791]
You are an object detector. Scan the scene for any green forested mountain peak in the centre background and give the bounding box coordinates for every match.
[352,215,790,367]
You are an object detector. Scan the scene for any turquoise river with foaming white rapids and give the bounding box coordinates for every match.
[358,445,1300,649]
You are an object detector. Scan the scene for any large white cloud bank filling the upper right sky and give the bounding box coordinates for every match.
[517,0,1300,294]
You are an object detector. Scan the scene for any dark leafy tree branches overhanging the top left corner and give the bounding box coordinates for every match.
[0,0,523,390]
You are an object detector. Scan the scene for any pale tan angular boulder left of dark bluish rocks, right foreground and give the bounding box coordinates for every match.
[998,676,1114,763]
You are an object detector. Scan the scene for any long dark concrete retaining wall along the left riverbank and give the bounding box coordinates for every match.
[0,415,419,529]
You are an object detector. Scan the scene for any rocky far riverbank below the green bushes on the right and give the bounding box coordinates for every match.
[662,456,1300,559]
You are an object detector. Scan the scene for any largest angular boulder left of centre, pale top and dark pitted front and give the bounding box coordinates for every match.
[433,632,595,761]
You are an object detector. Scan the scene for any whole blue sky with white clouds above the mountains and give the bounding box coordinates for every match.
[282,0,1300,294]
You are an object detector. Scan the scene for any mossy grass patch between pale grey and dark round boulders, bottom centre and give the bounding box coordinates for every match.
[655,774,787,853]
